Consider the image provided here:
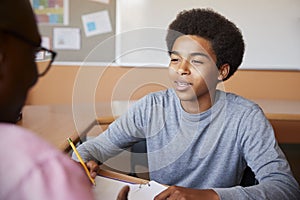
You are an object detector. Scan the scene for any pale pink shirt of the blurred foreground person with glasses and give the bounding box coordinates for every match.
[0,123,94,200]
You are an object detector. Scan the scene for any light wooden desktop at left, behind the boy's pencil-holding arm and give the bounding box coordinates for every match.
[18,103,119,152]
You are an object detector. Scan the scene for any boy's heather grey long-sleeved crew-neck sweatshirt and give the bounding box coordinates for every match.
[73,89,300,200]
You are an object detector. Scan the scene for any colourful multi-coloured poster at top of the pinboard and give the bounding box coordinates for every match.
[32,0,69,25]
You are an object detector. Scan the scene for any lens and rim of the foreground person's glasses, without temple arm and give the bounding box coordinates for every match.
[35,47,56,77]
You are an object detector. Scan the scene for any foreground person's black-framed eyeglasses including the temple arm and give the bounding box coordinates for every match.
[3,30,57,77]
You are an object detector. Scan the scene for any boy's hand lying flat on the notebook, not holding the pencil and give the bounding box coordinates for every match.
[154,186,219,200]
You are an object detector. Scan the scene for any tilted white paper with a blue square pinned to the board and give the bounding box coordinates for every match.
[81,10,112,37]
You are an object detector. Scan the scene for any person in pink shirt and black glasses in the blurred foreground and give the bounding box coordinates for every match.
[0,0,93,200]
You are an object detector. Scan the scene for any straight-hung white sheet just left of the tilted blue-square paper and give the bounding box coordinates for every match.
[53,28,80,50]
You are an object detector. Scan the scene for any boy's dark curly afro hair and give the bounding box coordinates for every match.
[166,8,245,81]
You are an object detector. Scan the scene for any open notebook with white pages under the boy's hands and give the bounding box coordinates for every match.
[94,176,167,200]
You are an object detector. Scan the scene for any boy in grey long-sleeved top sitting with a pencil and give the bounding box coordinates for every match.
[74,9,300,200]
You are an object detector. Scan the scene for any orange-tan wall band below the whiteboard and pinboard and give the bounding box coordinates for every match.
[27,66,300,105]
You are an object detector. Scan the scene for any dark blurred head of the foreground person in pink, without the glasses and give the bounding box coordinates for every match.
[0,0,41,123]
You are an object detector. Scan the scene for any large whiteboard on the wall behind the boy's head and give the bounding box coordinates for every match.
[116,0,300,70]
